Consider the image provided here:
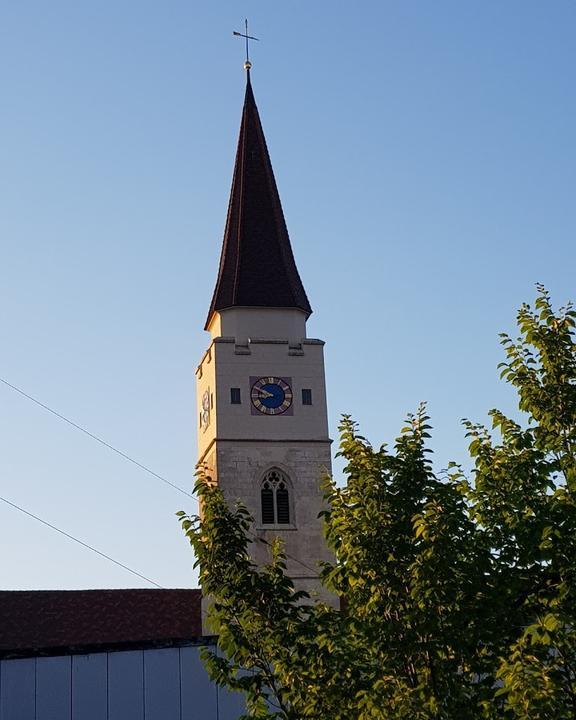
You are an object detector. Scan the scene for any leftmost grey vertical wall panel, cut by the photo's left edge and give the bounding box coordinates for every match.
[0,658,36,720]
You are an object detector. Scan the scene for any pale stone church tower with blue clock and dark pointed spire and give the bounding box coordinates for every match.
[196,64,331,599]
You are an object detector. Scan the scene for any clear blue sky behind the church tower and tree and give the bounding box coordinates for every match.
[0,0,576,589]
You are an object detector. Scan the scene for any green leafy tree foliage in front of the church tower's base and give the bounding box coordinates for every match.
[180,287,576,720]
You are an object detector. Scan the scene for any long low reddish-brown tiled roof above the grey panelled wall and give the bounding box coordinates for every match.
[0,590,202,657]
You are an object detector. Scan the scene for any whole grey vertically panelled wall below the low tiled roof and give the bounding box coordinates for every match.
[0,646,244,720]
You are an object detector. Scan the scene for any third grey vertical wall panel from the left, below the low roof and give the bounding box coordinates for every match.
[72,653,108,720]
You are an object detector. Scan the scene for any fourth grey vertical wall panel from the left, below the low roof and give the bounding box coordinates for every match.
[108,650,144,720]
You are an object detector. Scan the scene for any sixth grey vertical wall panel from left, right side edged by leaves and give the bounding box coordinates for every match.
[180,647,217,720]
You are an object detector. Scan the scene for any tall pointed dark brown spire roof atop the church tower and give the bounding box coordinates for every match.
[206,71,312,328]
